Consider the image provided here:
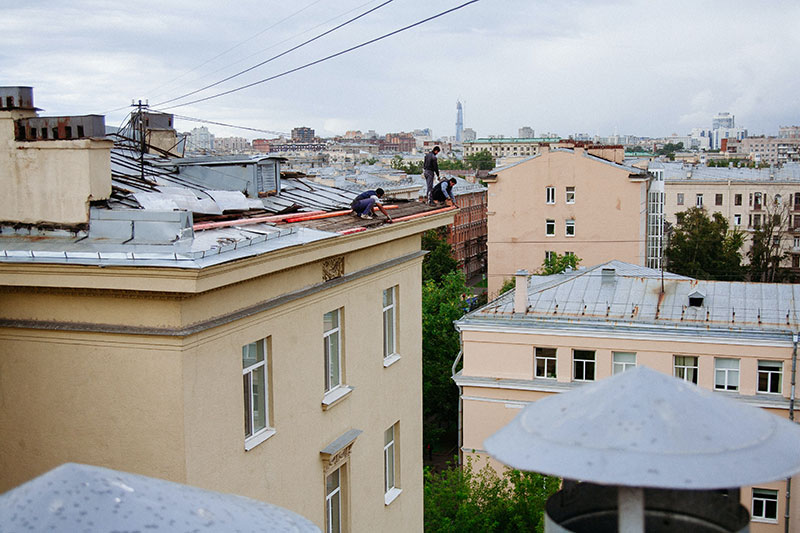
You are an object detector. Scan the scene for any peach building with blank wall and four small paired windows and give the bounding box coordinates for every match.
[484,143,650,295]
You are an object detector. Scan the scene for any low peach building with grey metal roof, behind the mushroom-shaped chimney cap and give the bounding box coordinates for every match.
[454,261,800,533]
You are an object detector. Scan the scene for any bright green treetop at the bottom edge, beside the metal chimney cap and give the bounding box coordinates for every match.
[425,458,560,533]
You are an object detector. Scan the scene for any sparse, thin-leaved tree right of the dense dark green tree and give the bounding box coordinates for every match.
[747,199,790,283]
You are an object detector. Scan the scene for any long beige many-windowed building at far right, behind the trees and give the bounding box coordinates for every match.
[647,161,800,269]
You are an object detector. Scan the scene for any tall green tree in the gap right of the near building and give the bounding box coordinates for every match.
[422,271,467,447]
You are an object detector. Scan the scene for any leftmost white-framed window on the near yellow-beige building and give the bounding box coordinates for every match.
[242,339,274,450]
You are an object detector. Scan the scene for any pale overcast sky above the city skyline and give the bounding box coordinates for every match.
[6,0,800,138]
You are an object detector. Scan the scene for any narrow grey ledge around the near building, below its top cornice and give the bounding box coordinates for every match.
[0,250,427,337]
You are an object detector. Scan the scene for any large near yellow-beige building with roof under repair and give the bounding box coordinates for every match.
[0,87,453,532]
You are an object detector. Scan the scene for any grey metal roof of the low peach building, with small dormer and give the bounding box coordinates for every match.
[467,261,800,331]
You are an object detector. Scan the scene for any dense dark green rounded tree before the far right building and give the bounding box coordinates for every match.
[665,207,744,281]
